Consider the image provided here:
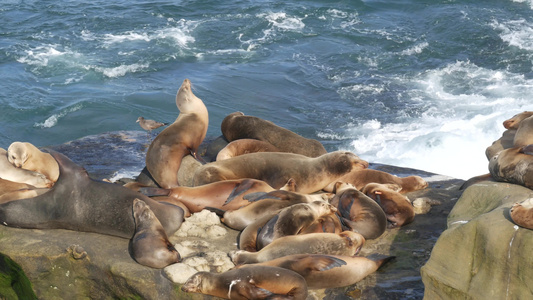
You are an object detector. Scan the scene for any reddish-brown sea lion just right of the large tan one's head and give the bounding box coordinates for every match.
[328,169,428,194]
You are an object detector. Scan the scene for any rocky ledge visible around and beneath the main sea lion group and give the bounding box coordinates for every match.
[0,132,464,299]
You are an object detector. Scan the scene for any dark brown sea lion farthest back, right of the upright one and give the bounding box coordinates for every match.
[221,112,327,157]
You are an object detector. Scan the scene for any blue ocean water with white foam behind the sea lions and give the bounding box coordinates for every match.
[0,0,533,179]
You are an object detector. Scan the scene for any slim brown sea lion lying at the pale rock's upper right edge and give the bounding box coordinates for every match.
[220,190,333,230]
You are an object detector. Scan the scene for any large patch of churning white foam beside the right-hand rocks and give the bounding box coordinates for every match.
[329,61,533,179]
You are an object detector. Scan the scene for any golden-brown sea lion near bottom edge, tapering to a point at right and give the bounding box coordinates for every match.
[236,254,395,289]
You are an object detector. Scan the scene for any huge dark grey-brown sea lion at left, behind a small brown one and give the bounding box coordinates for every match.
[0,151,183,239]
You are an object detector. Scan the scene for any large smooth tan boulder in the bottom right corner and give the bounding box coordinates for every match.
[421,182,533,299]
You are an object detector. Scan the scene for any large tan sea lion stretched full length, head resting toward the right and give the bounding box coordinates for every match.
[193,151,368,194]
